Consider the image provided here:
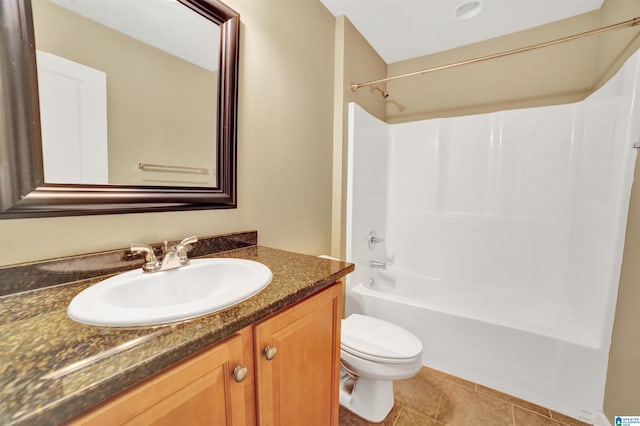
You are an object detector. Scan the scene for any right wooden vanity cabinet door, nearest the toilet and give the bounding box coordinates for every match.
[254,283,342,426]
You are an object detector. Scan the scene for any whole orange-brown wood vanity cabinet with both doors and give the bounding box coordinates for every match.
[70,282,343,426]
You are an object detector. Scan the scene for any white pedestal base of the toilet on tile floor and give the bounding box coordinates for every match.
[340,376,394,423]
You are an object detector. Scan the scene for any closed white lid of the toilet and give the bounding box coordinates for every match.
[340,314,422,360]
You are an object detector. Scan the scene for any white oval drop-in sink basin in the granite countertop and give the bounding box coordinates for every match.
[67,258,272,327]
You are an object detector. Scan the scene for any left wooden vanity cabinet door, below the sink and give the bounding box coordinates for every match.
[72,331,253,426]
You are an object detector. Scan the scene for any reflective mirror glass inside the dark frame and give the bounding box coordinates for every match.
[32,0,220,187]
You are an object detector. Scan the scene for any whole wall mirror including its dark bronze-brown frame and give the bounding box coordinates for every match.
[0,0,239,218]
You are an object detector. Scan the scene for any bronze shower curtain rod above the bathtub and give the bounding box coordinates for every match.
[351,17,640,92]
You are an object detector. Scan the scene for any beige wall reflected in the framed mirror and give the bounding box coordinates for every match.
[33,0,218,185]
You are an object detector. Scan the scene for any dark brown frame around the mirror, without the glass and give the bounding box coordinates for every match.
[0,0,240,219]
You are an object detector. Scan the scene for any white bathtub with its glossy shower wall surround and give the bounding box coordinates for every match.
[347,54,640,422]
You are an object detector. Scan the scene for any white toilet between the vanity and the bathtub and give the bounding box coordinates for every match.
[340,314,422,422]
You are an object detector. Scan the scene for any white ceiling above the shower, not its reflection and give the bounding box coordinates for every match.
[320,0,603,64]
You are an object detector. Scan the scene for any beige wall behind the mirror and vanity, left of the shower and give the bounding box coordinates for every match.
[0,0,335,265]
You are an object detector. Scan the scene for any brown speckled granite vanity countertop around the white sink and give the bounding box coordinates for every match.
[0,246,354,425]
